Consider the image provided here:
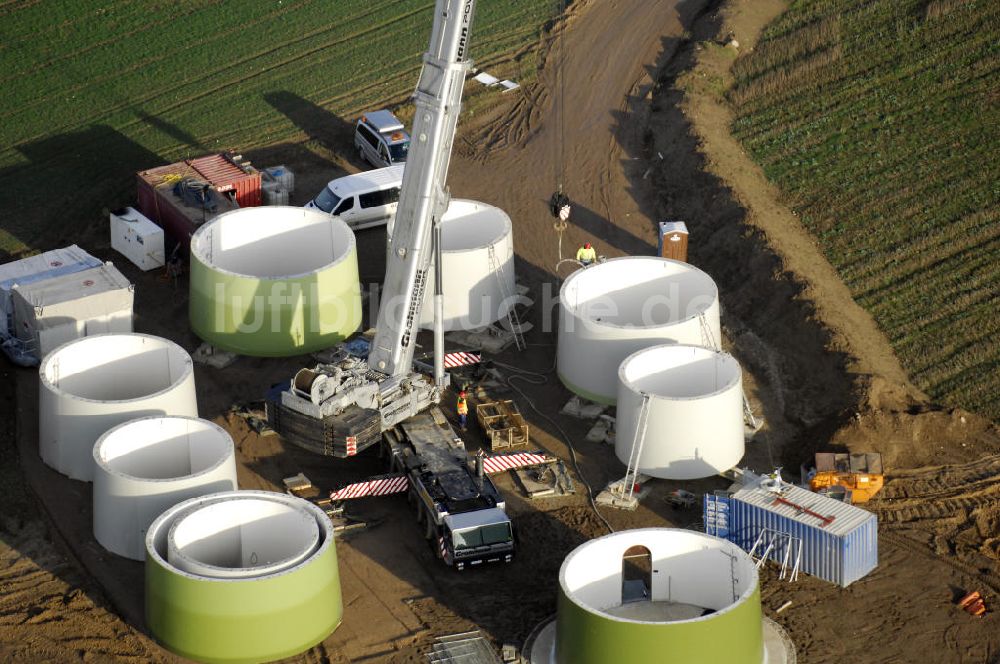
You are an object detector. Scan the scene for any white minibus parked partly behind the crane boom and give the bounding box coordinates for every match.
[305,164,406,230]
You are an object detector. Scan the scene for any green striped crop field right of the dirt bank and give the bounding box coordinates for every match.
[729,0,1000,419]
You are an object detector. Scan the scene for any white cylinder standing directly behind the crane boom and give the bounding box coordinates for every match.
[386,199,515,330]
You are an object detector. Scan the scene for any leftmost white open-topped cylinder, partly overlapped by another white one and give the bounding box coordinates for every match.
[38,334,198,482]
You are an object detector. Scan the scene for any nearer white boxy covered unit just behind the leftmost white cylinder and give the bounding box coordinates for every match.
[12,263,134,360]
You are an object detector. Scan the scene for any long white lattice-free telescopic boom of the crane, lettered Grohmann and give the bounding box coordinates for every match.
[368,0,476,378]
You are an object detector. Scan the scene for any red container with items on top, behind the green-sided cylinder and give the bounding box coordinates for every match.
[136,153,262,249]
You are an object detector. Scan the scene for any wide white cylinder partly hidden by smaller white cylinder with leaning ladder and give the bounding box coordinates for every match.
[556,256,722,405]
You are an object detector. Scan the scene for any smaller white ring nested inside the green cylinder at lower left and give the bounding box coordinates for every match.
[167,493,320,579]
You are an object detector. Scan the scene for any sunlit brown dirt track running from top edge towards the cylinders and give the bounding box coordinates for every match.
[450,0,688,276]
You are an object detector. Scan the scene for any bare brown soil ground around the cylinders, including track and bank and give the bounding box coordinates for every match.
[0,0,1000,664]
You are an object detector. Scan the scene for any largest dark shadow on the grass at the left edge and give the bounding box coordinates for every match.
[0,125,164,260]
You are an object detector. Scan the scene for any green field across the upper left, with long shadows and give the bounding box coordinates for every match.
[0,0,558,254]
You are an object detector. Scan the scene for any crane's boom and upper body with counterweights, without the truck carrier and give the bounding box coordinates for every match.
[268,0,476,448]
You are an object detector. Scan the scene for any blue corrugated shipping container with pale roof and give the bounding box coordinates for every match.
[704,480,878,587]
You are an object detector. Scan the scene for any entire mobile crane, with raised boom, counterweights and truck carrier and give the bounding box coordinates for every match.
[267,0,514,569]
